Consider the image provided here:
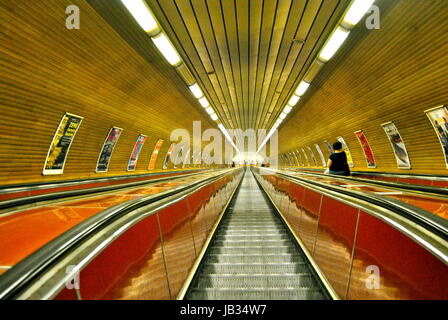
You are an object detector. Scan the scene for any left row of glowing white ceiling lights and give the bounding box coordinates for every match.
[121,0,239,153]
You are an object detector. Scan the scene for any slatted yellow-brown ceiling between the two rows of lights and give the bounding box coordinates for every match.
[89,0,349,129]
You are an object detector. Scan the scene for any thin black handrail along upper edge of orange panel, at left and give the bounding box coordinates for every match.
[0,171,210,211]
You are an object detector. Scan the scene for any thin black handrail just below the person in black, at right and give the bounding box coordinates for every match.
[292,170,448,196]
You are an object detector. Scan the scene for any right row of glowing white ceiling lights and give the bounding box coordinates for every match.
[257,0,375,152]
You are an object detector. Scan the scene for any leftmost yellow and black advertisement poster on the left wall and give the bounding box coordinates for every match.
[42,113,83,175]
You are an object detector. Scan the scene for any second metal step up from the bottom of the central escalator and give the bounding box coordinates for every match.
[197,273,316,289]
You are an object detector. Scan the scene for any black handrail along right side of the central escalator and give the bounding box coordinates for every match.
[275,172,448,239]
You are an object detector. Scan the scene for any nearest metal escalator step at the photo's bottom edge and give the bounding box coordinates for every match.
[190,288,325,300]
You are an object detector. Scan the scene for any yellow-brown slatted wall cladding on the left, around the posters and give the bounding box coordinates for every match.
[0,0,217,184]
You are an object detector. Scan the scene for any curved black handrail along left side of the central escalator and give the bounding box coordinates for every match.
[0,170,242,299]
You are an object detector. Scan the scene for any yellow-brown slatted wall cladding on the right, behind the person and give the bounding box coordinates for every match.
[279,0,448,175]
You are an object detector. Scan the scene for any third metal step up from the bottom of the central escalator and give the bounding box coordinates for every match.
[202,262,308,274]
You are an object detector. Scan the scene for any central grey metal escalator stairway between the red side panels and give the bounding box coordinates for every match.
[186,170,329,300]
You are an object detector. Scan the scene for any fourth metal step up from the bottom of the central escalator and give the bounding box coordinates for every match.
[205,253,305,263]
